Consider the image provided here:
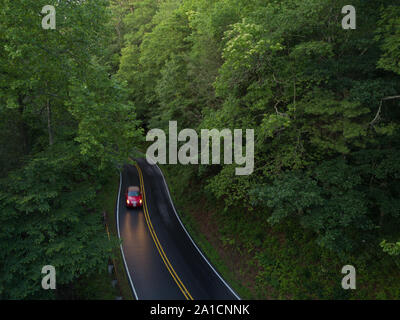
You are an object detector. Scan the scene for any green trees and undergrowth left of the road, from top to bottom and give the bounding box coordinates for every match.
[0,0,142,299]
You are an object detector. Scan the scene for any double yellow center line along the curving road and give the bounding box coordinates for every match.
[135,163,194,300]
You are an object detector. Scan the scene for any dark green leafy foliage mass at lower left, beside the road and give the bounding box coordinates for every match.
[0,144,115,299]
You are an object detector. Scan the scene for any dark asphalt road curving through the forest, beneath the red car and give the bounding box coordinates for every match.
[116,159,240,300]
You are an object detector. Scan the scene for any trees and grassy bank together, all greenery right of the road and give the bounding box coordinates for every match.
[112,0,400,299]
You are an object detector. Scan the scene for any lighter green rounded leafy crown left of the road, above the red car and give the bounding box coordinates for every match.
[66,67,143,168]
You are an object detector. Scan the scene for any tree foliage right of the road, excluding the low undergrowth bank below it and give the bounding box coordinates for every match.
[118,0,400,298]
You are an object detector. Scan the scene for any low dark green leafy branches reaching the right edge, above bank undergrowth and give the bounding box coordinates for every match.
[250,151,400,252]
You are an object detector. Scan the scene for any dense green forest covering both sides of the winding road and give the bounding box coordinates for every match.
[0,0,400,299]
